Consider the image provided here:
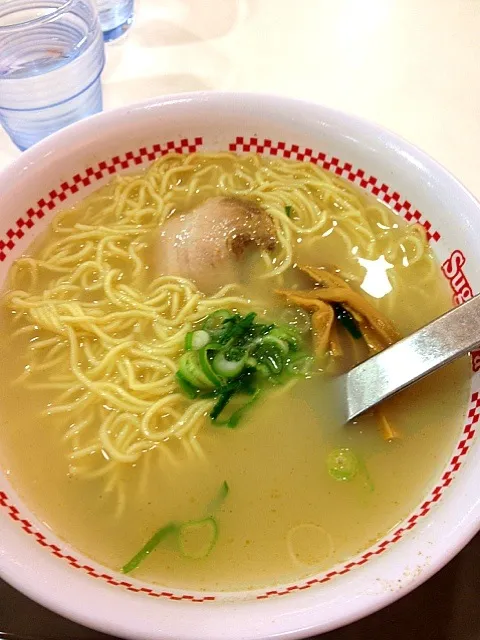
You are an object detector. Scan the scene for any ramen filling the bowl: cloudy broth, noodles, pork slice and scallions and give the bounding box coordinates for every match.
[0,153,469,590]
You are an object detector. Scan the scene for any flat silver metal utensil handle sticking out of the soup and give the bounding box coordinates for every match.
[343,295,480,421]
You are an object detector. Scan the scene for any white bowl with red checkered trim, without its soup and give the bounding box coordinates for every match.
[0,93,480,640]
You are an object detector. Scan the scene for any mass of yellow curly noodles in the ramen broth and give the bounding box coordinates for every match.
[6,153,437,512]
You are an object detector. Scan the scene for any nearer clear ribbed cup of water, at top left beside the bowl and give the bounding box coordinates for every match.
[0,0,105,150]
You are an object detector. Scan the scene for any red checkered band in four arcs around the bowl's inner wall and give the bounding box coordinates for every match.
[0,136,468,603]
